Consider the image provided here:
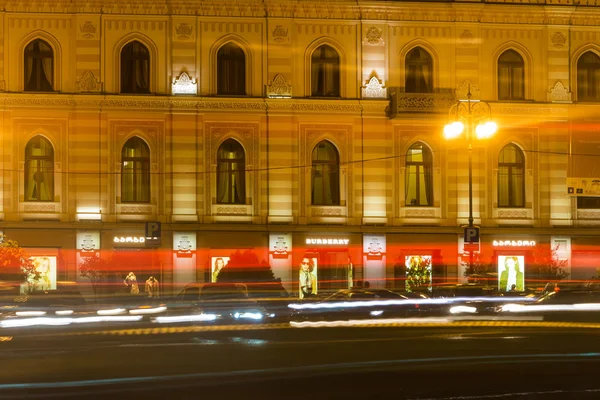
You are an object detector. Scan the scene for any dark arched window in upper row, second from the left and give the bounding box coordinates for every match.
[121,40,150,93]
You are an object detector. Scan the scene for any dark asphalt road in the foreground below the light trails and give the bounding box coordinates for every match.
[0,322,600,399]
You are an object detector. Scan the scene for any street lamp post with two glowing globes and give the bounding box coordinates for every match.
[444,85,498,280]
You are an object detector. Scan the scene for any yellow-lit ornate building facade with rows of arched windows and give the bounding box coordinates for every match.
[0,0,600,292]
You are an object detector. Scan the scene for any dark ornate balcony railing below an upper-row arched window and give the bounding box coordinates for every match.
[389,87,456,118]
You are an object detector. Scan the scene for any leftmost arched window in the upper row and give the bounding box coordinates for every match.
[24,39,54,92]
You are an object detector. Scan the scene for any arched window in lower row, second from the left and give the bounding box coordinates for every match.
[121,136,150,203]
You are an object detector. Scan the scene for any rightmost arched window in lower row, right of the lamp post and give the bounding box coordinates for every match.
[498,143,525,207]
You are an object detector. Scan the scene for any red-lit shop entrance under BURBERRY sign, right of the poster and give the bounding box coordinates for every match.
[306,249,353,292]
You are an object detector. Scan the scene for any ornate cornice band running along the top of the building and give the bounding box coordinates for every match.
[0,0,600,26]
